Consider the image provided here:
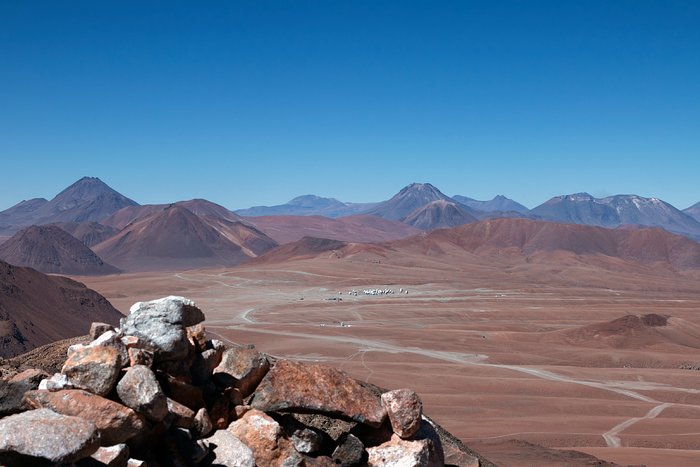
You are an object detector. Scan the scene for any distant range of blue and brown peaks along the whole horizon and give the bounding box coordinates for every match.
[0,177,700,275]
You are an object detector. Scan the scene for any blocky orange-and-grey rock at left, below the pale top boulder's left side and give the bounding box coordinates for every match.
[61,345,121,396]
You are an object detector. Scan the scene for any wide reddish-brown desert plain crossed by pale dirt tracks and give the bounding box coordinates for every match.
[79,252,700,466]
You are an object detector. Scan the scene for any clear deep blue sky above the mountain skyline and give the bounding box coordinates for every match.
[0,0,700,209]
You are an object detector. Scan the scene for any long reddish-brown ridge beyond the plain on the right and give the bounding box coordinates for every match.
[254,219,700,273]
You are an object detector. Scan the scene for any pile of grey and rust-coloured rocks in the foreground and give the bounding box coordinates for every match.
[0,297,479,467]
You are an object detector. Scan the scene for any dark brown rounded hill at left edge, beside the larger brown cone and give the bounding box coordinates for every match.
[0,225,119,276]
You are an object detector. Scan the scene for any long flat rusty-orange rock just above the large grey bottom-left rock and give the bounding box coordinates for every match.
[24,389,145,446]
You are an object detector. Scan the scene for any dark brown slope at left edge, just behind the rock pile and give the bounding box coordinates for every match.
[0,261,122,358]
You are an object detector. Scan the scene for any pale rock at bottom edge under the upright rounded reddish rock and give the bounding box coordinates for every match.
[367,436,444,467]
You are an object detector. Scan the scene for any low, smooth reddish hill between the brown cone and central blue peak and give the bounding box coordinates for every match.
[245,215,420,244]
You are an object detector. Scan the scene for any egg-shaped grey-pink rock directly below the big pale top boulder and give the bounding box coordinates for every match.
[117,365,168,422]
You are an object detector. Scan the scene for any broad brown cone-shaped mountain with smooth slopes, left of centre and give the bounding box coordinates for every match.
[95,205,248,271]
